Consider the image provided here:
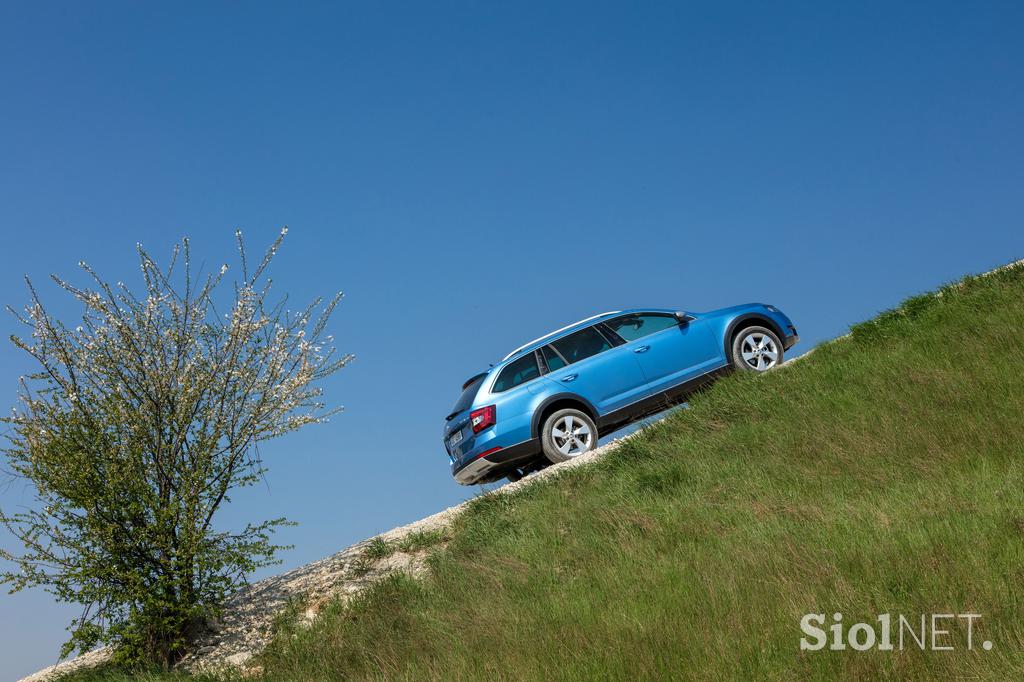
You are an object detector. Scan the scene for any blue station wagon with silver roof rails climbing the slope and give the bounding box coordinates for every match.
[444,303,800,485]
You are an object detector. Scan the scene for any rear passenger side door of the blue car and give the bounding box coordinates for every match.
[542,326,647,416]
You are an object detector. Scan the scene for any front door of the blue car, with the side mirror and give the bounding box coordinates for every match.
[604,312,722,396]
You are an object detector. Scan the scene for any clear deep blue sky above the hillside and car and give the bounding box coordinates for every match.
[0,2,1024,679]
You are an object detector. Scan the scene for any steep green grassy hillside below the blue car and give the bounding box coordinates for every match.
[74,265,1024,680]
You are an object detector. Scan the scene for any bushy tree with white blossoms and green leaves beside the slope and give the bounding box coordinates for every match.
[0,228,351,667]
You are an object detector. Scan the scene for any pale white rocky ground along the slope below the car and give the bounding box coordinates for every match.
[20,436,629,682]
